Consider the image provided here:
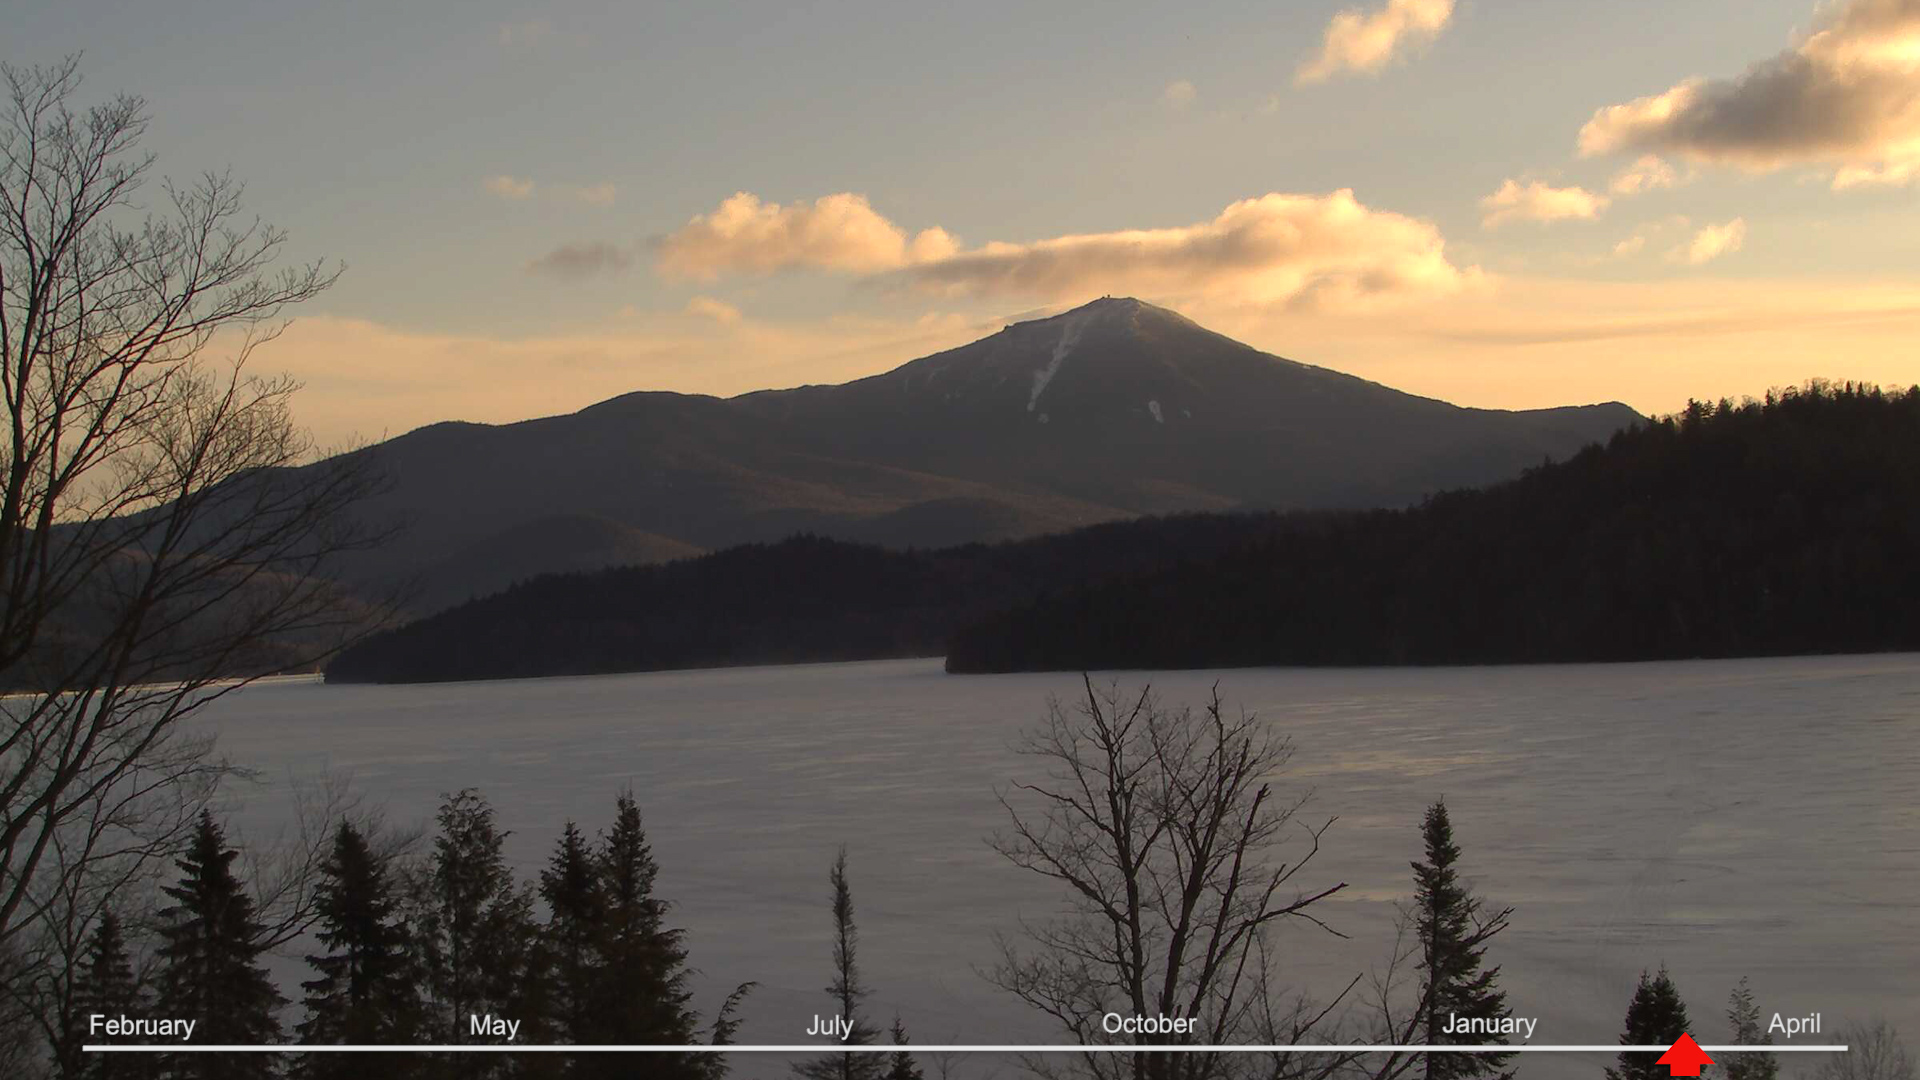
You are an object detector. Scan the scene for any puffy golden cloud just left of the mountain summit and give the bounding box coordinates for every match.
[655,192,958,281]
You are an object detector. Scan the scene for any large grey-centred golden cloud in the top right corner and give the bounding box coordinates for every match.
[1580,0,1920,188]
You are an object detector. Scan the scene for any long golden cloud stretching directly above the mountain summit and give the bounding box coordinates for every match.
[900,188,1478,307]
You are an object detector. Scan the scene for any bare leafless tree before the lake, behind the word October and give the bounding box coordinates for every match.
[991,678,1352,1080]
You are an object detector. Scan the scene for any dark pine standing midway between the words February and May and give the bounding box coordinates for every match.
[296,821,422,1080]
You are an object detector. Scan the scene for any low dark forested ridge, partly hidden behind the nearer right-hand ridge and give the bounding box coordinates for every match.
[326,513,1300,682]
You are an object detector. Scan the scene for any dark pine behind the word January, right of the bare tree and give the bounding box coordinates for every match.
[1413,801,1513,1080]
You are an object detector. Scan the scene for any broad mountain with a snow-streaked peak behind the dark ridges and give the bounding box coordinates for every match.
[314,298,1638,611]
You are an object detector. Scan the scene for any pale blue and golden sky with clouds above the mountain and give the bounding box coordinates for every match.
[15,0,1920,446]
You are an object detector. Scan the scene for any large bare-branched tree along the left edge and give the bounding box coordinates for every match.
[0,58,376,983]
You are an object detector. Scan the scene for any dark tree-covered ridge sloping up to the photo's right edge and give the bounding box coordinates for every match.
[947,384,1920,673]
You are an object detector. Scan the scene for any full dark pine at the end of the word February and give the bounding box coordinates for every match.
[154,811,286,1080]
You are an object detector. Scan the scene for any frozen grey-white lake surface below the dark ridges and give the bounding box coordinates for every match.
[198,655,1920,1076]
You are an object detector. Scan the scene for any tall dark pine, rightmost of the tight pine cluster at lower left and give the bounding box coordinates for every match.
[589,792,708,1080]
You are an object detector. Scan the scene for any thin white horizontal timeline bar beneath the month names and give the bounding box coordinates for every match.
[81,1043,1847,1053]
